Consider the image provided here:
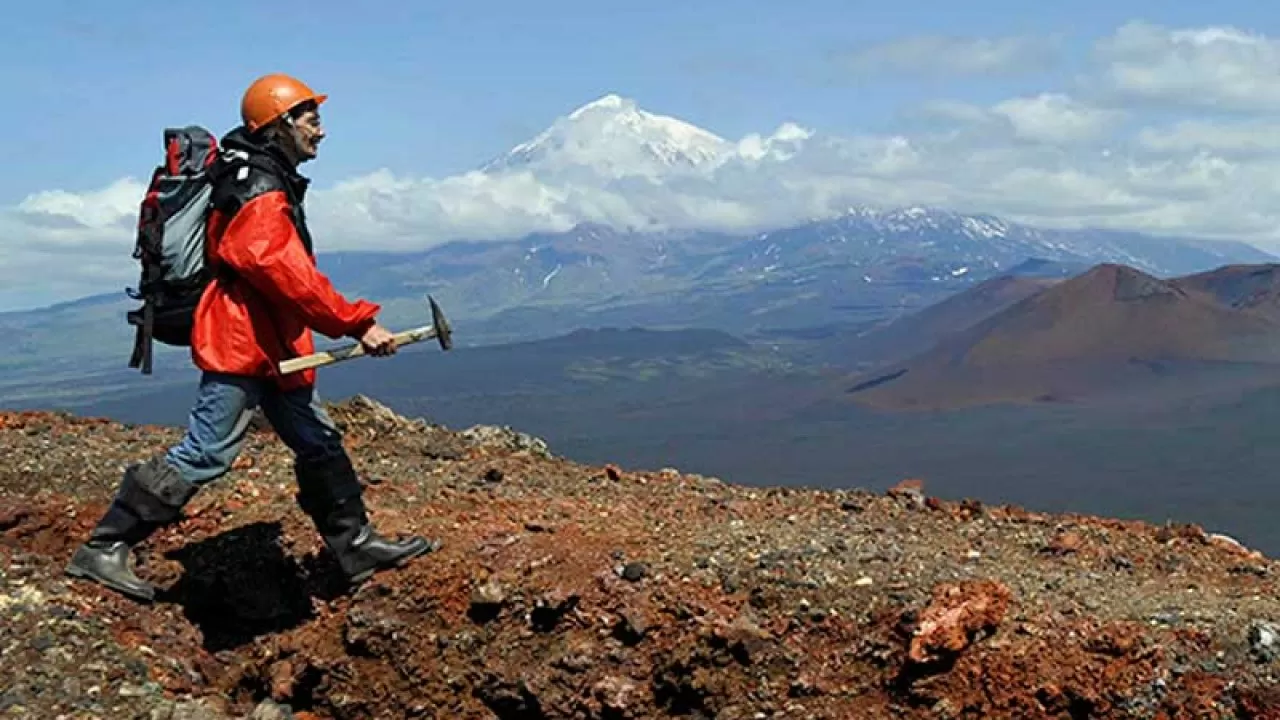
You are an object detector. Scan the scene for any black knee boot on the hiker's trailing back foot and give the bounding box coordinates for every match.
[67,456,198,602]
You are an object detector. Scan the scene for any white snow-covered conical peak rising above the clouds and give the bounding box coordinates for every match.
[481,94,733,178]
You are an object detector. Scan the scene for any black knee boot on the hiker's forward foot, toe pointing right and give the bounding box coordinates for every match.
[294,454,440,584]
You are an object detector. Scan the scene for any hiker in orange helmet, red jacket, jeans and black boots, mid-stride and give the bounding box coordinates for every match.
[67,74,439,601]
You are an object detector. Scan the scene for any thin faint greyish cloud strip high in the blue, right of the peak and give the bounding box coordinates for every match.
[837,35,1056,76]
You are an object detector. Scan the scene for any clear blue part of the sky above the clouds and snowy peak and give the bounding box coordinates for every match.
[0,0,1280,198]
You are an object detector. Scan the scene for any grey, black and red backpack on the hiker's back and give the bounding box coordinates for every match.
[125,126,219,375]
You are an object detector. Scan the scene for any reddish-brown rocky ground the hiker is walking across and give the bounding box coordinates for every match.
[0,397,1280,720]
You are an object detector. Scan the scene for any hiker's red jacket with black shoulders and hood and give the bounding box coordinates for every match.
[191,129,380,389]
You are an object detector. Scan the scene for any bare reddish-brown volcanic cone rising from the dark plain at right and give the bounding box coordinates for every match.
[852,264,1280,407]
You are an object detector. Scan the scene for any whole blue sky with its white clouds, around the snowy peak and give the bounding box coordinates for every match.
[0,0,1280,311]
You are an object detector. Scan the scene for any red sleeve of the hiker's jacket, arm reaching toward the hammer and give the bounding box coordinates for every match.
[209,191,381,340]
